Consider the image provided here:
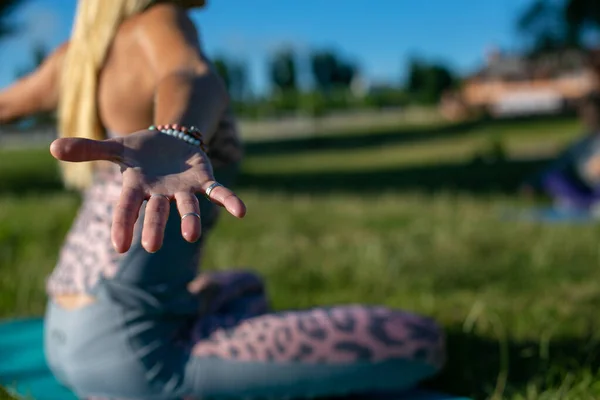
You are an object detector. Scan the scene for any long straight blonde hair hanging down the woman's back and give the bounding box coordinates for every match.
[58,0,155,190]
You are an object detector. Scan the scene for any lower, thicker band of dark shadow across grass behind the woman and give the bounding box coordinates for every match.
[238,159,549,194]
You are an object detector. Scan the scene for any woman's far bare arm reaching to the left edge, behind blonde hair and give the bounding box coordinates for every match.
[0,43,67,124]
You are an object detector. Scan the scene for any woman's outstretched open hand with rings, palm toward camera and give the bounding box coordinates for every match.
[50,130,246,253]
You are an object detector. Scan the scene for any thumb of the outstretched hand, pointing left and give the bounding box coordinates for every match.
[50,138,124,162]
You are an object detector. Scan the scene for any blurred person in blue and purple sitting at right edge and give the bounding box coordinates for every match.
[522,92,600,210]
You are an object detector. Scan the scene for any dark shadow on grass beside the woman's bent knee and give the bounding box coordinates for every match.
[425,328,600,399]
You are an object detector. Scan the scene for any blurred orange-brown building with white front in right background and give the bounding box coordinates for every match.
[440,46,600,120]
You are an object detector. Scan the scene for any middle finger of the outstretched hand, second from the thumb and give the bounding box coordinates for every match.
[142,195,170,253]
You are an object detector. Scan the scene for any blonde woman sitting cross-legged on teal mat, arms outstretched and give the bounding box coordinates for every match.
[0,0,443,400]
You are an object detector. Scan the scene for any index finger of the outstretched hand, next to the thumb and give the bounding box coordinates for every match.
[111,184,144,253]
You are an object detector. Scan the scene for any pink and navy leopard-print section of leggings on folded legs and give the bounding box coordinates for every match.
[185,271,444,367]
